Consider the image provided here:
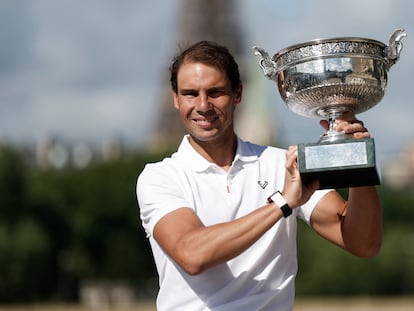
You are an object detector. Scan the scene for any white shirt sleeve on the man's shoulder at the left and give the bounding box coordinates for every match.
[136,163,190,237]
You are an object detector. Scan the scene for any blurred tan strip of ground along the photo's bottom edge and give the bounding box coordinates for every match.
[0,297,414,311]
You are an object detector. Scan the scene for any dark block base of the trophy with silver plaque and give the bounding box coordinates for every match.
[298,138,380,189]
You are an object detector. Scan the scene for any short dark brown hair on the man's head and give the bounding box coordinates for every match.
[170,41,241,93]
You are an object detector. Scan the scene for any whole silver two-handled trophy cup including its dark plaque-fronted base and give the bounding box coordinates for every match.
[253,29,406,189]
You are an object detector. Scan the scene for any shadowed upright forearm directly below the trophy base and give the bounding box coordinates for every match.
[342,187,382,257]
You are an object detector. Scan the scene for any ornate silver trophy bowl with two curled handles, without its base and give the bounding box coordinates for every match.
[253,29,406,118]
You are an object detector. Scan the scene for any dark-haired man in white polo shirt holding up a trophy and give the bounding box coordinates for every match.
[137,41,382,311]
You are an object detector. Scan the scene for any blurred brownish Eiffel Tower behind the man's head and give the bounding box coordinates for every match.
[150,0,271,151]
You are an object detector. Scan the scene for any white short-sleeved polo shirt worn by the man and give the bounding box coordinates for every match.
[137,136,327,311]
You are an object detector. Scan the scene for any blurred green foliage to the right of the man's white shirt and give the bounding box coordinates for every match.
[296,186,414,296]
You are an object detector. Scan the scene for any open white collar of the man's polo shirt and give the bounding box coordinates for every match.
[176,134,258,172]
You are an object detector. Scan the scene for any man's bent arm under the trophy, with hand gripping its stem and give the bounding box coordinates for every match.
[311,114,382,257]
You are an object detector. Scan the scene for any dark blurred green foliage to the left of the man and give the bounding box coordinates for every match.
[0,147,168,302]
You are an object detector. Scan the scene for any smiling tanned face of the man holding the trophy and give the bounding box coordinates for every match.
[174,62,242,142]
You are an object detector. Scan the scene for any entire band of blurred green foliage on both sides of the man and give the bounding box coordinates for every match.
[0,147,414,302]
